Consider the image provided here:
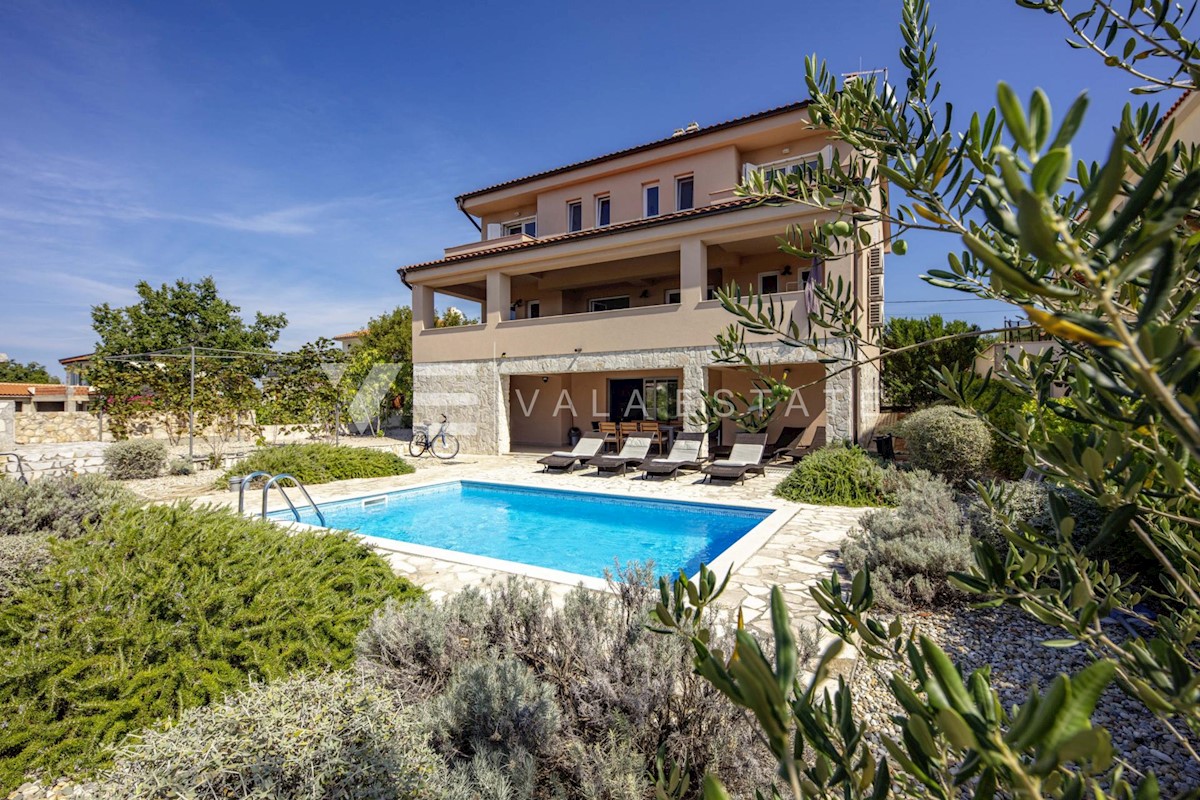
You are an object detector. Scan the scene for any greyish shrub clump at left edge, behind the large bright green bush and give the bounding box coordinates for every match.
[0,475,133,597]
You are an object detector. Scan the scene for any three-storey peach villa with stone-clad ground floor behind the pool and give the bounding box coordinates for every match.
[398,103,887,453]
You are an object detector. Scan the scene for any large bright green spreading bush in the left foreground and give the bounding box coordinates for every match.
[0,505,414,788]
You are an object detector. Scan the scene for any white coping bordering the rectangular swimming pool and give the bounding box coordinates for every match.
[268,477,797,591]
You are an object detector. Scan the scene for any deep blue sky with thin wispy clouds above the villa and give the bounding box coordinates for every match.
[0,0,1174,371]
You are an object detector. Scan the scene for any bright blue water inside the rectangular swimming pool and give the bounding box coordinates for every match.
[270,481,770,577]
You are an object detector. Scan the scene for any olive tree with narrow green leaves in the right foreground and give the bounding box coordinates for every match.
[656,0,1200,798]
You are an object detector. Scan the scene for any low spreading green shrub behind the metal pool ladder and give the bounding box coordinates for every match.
[217,444,413,486]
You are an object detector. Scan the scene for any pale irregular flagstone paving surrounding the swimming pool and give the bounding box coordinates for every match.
[184,455,864,652]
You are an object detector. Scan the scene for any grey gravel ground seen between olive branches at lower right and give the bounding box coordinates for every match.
[851,608,1200,795]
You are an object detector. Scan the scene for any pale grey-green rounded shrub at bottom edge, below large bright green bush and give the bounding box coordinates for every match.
[104,673,440,800]
